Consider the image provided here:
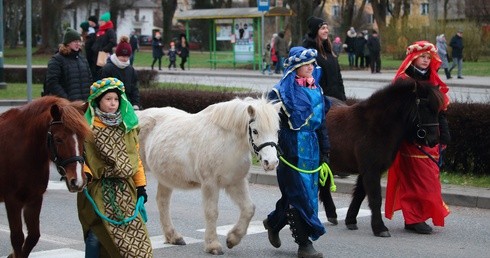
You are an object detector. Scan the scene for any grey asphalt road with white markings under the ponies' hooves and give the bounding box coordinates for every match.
[0,169,490,258]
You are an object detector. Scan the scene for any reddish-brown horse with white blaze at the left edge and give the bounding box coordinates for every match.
[0,96,90,258]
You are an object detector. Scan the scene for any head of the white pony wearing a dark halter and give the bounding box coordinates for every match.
[247,99,280,171]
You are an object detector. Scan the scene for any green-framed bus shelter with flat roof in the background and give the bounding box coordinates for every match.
[175,7,294,70]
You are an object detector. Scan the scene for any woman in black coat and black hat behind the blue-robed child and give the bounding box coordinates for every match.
[303,17,347,101]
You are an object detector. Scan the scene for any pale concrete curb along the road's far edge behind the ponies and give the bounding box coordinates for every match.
[249,166,490,209]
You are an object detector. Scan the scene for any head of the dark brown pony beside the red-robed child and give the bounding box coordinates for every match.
[411,82,443,147]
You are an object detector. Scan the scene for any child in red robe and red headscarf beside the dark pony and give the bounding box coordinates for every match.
[385,41,450,234]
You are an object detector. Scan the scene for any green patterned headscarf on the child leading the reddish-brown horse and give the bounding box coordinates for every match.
[85,77,138,132]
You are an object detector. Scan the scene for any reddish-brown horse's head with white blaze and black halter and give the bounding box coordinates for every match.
[47,102,90,192]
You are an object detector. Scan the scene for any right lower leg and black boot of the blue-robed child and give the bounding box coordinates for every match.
[287,208,323,258]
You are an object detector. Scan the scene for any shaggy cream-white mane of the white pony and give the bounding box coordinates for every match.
[202,97,279,133]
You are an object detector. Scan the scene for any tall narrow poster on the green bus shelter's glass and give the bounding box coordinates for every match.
[234,19,254,62]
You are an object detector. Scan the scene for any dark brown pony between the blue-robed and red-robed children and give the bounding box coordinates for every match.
[320,79,443,237]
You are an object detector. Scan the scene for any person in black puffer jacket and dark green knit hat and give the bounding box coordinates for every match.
[42,28,92,101]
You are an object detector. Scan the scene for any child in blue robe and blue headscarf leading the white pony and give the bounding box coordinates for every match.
[264,47,330,257]
